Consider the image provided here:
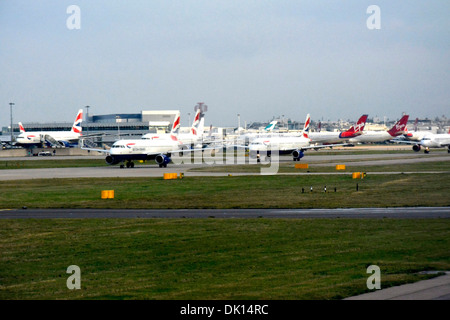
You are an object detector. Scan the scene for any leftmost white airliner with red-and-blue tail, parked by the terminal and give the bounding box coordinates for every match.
[15,109,83,148]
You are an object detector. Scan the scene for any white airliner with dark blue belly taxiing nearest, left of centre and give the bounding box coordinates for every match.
[81,114,213,168]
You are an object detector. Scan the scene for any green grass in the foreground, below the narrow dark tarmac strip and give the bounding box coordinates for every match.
[0,219,450,300]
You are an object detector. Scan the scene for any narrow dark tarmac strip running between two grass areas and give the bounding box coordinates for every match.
[0,207,450,219]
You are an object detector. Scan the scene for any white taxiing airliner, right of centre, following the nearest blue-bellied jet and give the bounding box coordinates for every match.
[248,114,349,161]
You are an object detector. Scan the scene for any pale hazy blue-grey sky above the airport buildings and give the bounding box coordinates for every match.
[0,0,450,126]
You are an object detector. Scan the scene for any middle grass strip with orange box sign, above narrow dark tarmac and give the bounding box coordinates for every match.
[0,173,450,209]
